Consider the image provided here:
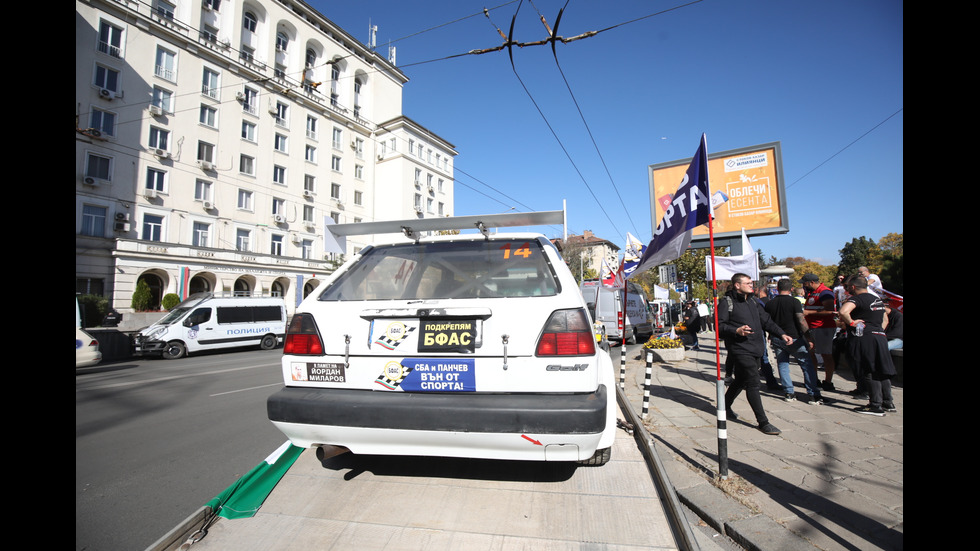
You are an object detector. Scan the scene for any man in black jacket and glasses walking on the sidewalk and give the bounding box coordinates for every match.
[718,273,793,434]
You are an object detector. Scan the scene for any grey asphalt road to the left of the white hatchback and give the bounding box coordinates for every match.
[75,349,286,551]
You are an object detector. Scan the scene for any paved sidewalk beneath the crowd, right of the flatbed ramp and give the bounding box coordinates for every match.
[610,332,905,551]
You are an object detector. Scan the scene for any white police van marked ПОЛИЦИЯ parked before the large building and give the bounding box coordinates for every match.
[133,293,286,360]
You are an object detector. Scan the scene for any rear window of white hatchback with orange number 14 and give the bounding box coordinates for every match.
[319,239,559,301]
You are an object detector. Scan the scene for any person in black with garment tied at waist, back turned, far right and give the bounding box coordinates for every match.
[839,273,896,417]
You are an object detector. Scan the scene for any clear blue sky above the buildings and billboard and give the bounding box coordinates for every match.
[308,0,904,264]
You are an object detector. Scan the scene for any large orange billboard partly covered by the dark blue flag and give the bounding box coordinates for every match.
[649,142,789,241]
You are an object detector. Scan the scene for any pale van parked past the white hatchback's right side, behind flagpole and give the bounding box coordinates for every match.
[579,280,653,344]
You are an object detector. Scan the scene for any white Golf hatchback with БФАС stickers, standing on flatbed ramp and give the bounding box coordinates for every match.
[268,211,616,465]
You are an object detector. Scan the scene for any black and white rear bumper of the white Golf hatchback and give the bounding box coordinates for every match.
[268,386,615,461]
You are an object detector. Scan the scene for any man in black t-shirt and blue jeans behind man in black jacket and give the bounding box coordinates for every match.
[766,279,823,405]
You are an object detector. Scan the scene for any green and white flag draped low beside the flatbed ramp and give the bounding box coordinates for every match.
[206,441,303,519]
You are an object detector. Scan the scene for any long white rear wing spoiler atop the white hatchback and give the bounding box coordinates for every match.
[324,210,565,252]
